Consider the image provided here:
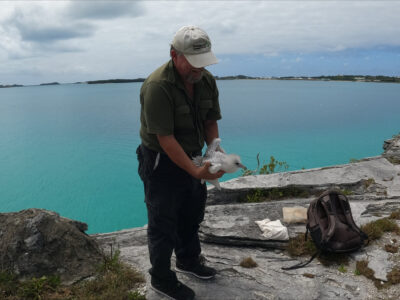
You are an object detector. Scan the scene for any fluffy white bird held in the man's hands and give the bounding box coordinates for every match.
[193,138,246,190]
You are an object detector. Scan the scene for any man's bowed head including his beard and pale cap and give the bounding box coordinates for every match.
[171,26,218,83]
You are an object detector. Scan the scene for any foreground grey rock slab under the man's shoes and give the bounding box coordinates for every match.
[97,231,371,300]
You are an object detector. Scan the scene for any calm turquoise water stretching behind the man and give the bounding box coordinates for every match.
[0,80,400,233]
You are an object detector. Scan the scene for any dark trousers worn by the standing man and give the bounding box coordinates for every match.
[136,145,207,281]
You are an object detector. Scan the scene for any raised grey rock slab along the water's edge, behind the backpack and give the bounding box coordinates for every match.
[209,156,400,204]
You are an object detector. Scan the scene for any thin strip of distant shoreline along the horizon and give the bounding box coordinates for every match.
[0,75,400,88]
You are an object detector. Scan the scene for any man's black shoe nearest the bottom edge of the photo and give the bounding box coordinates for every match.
[151,279,194,300]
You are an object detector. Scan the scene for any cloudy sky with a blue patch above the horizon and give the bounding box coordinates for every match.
[0,0,400,84]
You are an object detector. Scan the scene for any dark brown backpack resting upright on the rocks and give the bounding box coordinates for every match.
[282,190,368,270]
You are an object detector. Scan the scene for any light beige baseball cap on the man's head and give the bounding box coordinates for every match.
[171,25,218,68]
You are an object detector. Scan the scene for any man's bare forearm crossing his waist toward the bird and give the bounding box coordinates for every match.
[157,134,224,180]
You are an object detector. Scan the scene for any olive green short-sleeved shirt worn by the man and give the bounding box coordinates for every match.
[140,60,221,153]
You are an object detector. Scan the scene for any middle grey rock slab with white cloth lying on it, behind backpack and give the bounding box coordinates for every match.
[199,198,400,249]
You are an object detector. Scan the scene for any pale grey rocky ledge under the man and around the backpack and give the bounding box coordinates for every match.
[93,135,400,300]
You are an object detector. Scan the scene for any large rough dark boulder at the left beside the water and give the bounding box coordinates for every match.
[0,209,102,283]
